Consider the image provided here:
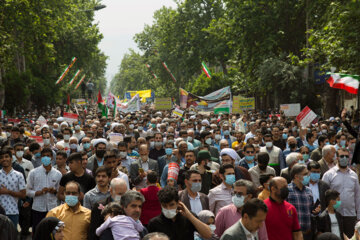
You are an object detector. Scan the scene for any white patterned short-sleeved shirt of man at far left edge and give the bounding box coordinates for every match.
[0,169,26,215]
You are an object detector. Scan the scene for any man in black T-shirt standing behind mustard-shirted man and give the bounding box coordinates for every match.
[57,153,96,203]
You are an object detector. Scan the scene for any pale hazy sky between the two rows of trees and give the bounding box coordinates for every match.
[94,0,176,84]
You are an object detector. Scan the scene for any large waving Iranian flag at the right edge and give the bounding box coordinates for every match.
[327,73,360,94]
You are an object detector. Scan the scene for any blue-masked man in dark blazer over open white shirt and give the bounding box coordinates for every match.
[179,170,209,215]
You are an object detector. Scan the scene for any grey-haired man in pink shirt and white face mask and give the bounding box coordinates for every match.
[215,179,268,240]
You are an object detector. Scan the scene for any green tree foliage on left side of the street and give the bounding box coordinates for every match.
[0,0,106,110]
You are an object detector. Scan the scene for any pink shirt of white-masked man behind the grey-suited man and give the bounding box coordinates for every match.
[215,204,268,240]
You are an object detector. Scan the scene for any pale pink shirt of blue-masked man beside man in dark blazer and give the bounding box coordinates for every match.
[208,183,232,215]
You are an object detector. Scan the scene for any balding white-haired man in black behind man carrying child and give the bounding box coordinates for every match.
[88,178,128,240]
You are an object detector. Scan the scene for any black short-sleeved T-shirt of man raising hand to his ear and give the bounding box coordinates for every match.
[148,213,196,240]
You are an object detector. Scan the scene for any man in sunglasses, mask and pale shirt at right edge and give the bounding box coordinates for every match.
[322,148,360,236]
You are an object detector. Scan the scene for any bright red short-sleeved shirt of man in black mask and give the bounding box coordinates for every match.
[264,198,301,240]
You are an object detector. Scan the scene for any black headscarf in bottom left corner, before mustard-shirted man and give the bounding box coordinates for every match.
[34,217,64,240]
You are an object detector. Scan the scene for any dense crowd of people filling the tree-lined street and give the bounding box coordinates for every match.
[0,105,360,240]
